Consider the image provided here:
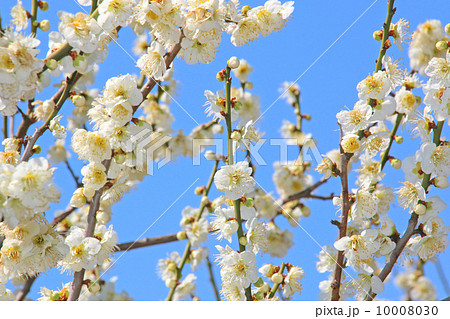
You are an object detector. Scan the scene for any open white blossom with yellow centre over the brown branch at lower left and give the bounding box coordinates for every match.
[61,227,102,272]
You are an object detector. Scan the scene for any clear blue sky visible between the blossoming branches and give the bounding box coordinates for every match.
[0,0,450,300]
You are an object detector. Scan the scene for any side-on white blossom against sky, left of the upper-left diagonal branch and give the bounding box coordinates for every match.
[137,40,166,80]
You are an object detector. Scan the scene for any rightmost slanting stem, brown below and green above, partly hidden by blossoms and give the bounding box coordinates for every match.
[364,121,445,301]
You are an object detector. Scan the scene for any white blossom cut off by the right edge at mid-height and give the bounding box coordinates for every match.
[416,143,450,176]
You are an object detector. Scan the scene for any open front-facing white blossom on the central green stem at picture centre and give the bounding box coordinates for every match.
[214,161,255,200]
